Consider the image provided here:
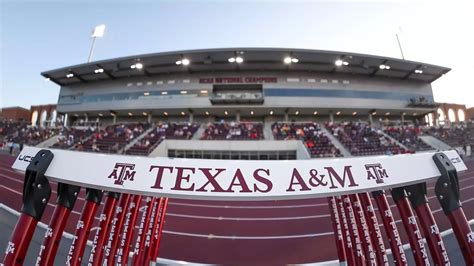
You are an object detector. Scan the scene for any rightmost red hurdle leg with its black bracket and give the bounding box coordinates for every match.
[433,153,474,265]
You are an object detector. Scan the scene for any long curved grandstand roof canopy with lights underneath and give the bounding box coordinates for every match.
[41,48,451,85]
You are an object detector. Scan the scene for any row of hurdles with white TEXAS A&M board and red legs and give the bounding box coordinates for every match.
[3,147,474,265]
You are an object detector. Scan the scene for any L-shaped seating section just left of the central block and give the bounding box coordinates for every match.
[125,123,199,156]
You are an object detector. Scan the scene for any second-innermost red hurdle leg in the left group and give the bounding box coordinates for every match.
[132,197,156,266]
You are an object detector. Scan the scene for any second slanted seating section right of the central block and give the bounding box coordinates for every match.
[326,122,409,156]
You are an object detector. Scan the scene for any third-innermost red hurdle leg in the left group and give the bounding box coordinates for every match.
[116,195,142,265]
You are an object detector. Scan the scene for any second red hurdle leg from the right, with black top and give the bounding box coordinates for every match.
[405,183,449,265]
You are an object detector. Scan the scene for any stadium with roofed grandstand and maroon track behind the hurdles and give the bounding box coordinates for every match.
[0,47,474,265]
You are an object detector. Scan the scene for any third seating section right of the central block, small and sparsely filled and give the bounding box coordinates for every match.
[384,126,433,151]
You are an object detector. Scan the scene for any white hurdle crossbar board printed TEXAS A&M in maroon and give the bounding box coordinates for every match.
[13,147,467,200]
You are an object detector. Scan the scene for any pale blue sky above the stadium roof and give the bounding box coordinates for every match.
[0,0,474,108]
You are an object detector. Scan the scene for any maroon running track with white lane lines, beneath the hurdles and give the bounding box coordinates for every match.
[0,154,474,265]
